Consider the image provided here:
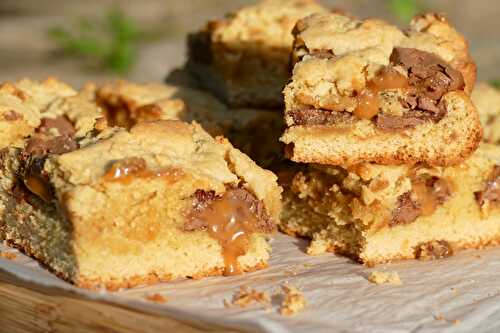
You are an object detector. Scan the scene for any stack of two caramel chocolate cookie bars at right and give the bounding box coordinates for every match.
[280,14,500,264]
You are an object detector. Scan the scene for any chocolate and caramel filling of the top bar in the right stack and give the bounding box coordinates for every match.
[287,47,465,131]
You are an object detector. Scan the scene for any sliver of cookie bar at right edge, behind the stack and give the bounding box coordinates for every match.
[472,82,500,144]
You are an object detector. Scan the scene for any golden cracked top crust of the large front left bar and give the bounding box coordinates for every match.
[45,120,281,221]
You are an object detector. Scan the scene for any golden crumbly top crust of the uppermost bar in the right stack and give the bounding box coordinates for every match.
[294,13,476,93]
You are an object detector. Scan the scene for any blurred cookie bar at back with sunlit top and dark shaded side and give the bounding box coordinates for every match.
[187,0,326,108]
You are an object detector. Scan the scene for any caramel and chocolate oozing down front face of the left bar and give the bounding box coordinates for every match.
[184,188,273,275]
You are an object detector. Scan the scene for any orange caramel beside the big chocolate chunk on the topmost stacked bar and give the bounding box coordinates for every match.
[353,67,409,119]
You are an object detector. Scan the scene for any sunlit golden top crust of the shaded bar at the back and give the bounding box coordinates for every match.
[208,0,326,49]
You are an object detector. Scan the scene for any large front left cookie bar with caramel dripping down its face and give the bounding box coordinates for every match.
[0,121,281,289]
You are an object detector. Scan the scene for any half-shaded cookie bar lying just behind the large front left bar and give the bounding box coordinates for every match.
[95,81,284,168]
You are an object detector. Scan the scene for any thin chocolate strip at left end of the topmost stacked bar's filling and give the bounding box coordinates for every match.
[288,109,354,125]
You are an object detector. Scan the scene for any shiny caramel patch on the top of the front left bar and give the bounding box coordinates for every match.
[103,157,181,185]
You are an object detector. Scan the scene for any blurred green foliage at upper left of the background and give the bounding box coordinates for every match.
[48,7,161,75]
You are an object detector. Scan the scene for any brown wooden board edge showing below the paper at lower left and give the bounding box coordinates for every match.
[0,272,237,333]
